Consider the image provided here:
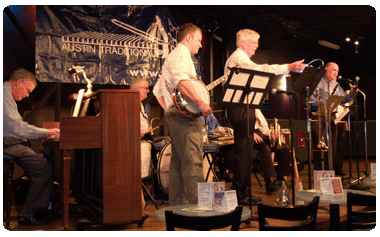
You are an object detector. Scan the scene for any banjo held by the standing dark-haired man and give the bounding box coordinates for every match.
[172,74,228,119]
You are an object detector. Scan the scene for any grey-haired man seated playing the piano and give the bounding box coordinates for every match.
[3,68,59,225]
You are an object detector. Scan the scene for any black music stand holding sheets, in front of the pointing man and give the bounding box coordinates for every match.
[221,67,276,213]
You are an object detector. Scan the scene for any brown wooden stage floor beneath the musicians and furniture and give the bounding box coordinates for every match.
[3,159,376,231]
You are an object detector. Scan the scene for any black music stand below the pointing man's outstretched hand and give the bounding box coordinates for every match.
[292,66,326,189]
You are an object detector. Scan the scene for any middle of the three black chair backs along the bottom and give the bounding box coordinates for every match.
[257,196,319,231]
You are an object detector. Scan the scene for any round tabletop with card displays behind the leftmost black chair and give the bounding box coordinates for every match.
[156,204,251,222]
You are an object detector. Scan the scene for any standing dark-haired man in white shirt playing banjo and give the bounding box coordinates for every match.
[153,23,212,205]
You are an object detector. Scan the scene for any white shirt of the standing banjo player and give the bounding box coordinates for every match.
[153,44,197,108]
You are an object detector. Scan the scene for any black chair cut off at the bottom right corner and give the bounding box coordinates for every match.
[347,193,376,231]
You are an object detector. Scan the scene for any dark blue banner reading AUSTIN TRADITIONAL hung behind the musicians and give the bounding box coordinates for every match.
[36,5,202,86]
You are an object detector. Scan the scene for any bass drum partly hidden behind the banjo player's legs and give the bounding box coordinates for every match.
[157,143,214,195]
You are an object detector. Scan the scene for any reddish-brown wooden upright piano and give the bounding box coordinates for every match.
[60,89,142,227]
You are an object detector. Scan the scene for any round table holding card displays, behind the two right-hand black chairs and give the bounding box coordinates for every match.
[296,189,373,230]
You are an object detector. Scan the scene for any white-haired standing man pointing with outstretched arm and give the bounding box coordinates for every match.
[224,29,305,204]
